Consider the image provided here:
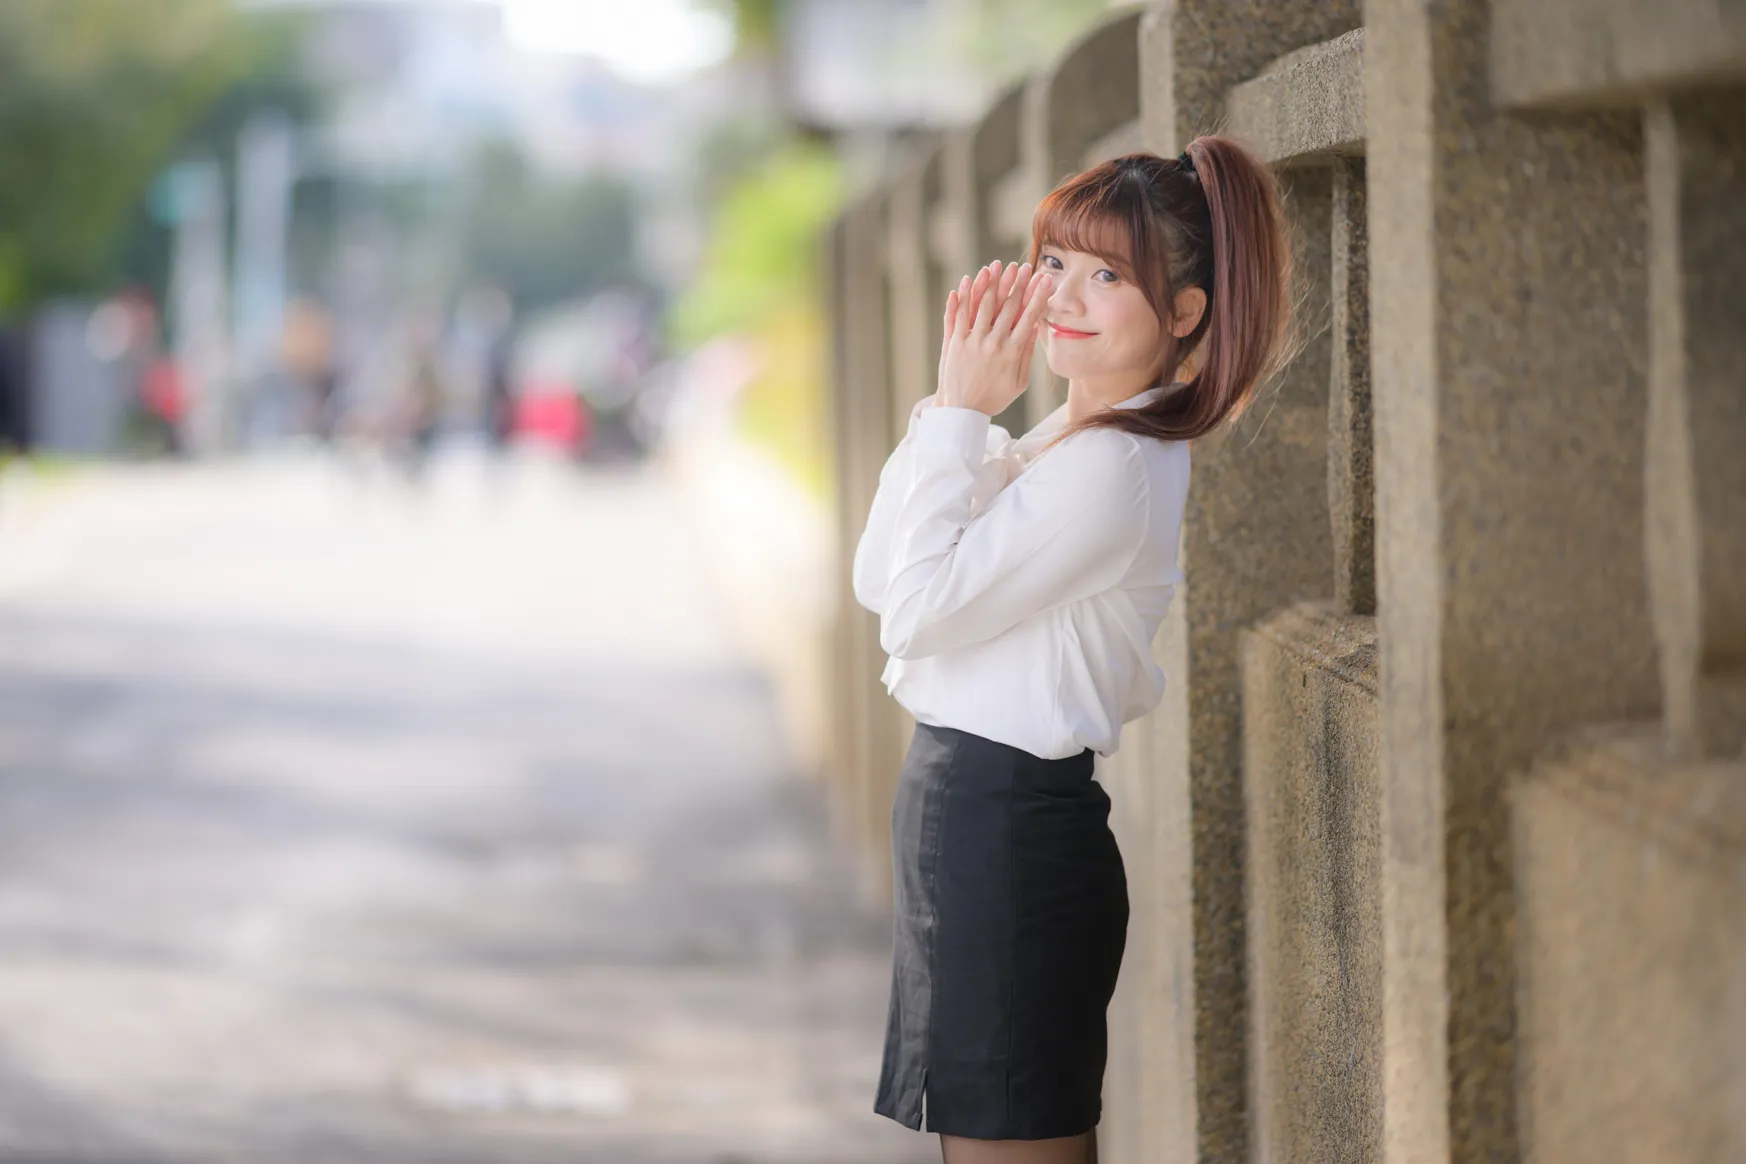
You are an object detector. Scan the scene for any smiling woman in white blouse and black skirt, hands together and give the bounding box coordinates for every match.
[854,136,1290,1164]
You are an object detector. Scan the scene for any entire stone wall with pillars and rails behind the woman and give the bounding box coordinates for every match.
[828,0,1746,1164]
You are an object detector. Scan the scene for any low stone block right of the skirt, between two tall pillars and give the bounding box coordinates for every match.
[1241,606,1383,1164]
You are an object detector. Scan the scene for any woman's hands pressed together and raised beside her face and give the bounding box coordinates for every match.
[934,262,1055,415]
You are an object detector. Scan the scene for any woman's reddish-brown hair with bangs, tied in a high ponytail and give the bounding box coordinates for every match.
[1030,134,1292,445]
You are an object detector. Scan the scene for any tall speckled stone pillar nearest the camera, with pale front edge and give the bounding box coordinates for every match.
[1365,0,1659,1162]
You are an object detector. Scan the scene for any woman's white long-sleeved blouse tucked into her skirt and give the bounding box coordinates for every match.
[854,386,1189,759]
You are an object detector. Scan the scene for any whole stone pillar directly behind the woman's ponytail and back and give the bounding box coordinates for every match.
[1140,0,1360,1162]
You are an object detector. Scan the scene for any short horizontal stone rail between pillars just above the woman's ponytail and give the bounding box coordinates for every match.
[1226,28,1364,162]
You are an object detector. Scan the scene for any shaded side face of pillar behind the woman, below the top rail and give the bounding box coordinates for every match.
[1156,161,1334,1159]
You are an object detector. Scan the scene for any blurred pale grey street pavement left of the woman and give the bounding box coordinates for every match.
[0,450,938,1164]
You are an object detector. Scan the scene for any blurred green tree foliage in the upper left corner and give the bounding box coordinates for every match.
[0,0,268,316]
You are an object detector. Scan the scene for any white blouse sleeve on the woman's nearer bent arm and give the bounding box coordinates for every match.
[880,407,1149,658]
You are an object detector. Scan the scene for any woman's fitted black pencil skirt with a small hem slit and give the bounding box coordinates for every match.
[873,724,1128,1140]
